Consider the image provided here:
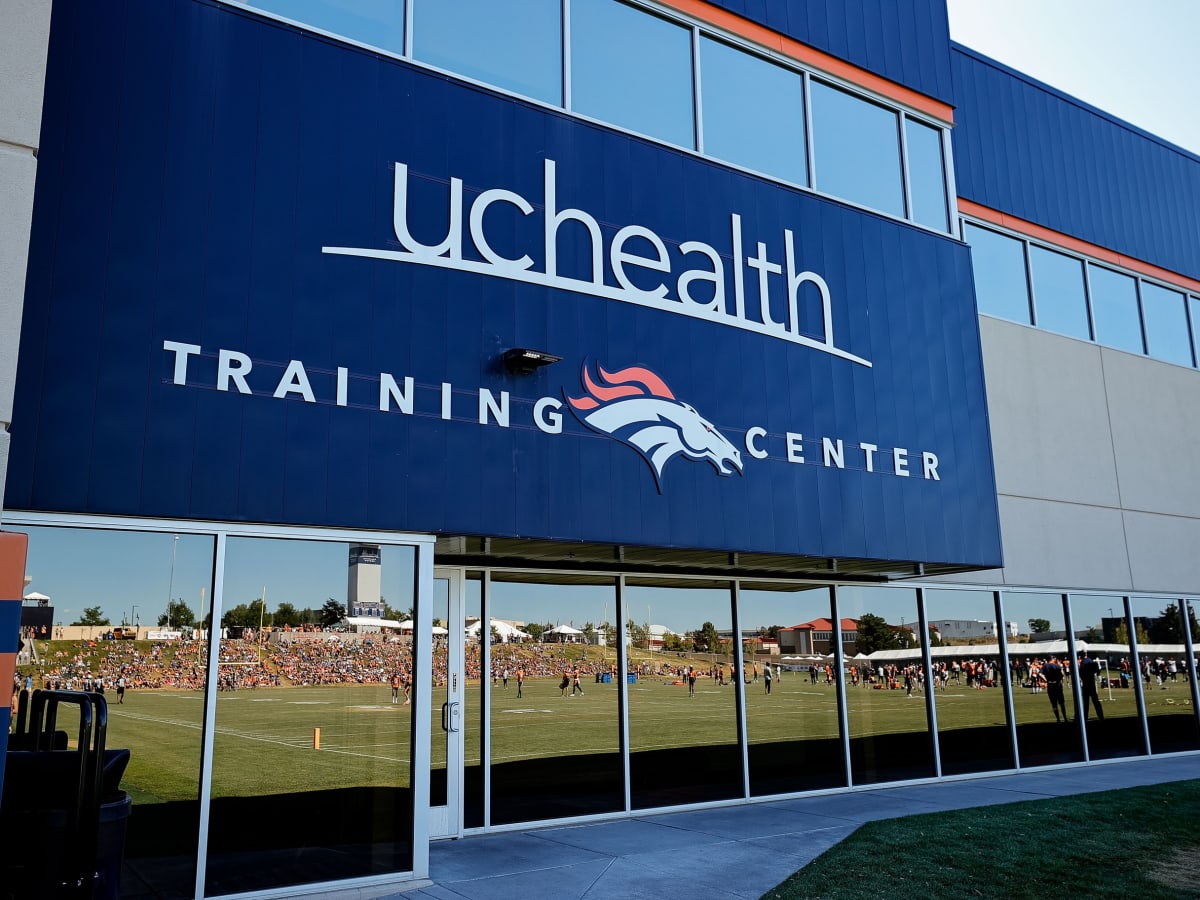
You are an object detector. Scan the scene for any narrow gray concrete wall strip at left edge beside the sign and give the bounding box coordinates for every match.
[0,0,52,512]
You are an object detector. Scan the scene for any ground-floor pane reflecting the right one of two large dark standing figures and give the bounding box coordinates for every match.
[1070,594,1145,760]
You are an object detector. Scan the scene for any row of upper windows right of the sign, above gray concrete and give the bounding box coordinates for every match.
[964,222,1200,366]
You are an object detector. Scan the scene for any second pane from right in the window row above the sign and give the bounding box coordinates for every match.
[811,82,905,218]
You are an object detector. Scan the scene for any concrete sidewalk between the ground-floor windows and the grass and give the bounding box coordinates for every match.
[391,755,1200,900]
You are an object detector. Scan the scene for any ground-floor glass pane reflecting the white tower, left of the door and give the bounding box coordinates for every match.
[205,538,416,894]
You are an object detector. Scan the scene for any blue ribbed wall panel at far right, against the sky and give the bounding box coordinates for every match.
[952,47,1200,278]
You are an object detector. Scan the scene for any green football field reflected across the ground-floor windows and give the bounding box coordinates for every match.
[108,673,1192,804]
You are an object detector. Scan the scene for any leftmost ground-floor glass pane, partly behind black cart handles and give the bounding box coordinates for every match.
[16,527,216,896]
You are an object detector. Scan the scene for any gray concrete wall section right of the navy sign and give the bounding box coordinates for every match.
[962,317,1200,595]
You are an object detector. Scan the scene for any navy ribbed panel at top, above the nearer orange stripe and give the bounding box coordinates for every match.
[709,0,954,103]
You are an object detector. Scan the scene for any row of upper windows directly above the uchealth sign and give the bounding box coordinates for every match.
[236,0,950,232]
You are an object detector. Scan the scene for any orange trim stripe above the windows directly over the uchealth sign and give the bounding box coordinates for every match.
[659,0,954,125]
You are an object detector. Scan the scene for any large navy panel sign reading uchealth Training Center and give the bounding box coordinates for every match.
[5,0,1002,565]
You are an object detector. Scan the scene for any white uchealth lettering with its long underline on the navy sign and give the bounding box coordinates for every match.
[322,160,871,367]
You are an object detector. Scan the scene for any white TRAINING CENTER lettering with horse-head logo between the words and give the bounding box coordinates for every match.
[162,341,941,493]
